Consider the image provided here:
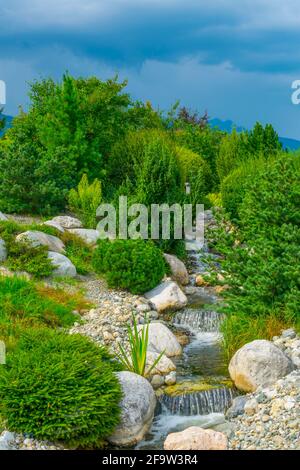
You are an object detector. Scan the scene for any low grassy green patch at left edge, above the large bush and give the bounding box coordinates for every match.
[0,276,76,326]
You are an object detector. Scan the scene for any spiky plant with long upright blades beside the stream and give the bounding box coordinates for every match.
[118,315,164,377]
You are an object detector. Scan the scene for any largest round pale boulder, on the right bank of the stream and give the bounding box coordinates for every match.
[229,340,294,392]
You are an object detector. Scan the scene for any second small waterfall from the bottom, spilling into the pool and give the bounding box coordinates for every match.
[174,308,224,333]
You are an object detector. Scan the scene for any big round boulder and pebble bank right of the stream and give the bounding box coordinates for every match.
[226,329,300,450]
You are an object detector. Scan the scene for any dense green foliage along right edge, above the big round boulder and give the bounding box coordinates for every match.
[211,154,300,356]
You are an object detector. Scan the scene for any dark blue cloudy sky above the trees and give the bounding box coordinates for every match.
[0,0,300,139]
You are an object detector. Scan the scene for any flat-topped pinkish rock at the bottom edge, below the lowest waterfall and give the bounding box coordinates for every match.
[164,426,227,450]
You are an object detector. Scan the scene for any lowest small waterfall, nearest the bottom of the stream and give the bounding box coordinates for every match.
[159,387,235,416]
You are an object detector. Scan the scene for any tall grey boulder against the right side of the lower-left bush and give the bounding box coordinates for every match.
[108,371,156,446]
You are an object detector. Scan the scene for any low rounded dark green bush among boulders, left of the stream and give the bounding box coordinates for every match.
[93,239,165,294]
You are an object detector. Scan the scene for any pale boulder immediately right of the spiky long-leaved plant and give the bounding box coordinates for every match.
[138,322,182,357]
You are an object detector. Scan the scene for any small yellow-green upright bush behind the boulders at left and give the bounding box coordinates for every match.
[69,174,102,228]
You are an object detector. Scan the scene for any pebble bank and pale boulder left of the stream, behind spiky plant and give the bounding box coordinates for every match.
[70,278,182,388]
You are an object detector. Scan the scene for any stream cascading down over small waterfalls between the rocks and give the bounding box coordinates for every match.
[135,237,236,450]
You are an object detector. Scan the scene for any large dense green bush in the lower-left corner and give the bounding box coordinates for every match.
[0,329,122,447]
